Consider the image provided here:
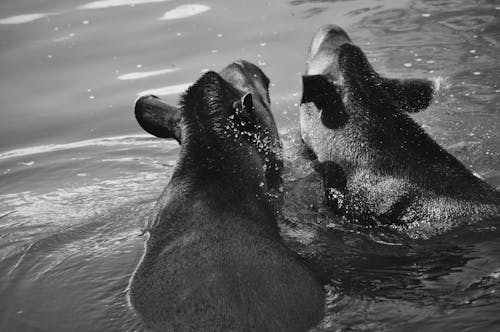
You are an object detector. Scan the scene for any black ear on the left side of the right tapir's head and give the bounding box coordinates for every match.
[300,75,348,129]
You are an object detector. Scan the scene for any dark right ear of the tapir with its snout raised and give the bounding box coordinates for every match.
[382,78,434,113]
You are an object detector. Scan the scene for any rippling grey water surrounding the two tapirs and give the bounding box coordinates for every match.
[0,0,500,331]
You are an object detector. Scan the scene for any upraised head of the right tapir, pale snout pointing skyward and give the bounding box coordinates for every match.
[300,26,435,173]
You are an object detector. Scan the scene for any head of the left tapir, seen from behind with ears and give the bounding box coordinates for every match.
[135,60,283,189]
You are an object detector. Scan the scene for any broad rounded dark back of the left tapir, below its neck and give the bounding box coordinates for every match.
[130,192,323,331]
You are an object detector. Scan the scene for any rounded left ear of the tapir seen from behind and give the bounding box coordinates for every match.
[135,95,181,143]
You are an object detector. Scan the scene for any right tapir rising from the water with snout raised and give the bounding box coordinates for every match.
[300,25,500,239]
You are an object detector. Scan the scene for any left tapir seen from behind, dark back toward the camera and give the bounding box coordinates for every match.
[129,63,325,331]
